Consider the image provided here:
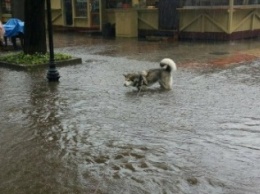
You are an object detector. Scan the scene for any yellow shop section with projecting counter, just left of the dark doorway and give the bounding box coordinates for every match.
[104,0,159,37]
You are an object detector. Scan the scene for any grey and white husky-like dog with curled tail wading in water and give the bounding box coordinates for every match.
[124,58,177,91]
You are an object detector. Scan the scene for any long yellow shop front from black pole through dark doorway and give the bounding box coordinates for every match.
[52,0,178,37]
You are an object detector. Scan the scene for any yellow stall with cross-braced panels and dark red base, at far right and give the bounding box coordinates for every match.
[178,0,260,40]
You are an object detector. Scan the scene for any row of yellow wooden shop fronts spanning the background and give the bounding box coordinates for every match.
[0,0,260,40]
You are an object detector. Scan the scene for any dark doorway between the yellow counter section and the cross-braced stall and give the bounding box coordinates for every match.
[158,0,179,30]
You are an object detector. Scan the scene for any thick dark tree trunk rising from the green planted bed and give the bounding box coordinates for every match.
[24,0,47,55]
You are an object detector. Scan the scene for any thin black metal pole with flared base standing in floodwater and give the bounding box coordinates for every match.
[46,0,60,82]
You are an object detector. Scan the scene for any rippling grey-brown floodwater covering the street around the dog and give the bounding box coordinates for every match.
[0,32,260,194]
